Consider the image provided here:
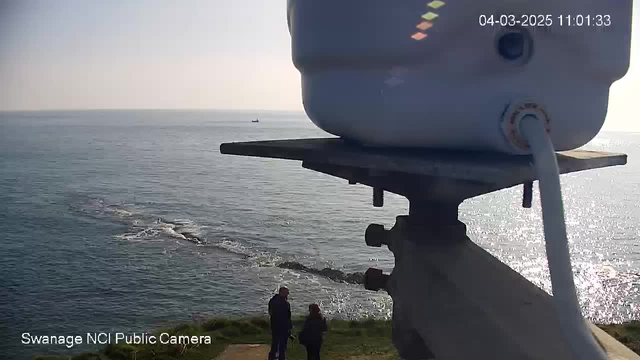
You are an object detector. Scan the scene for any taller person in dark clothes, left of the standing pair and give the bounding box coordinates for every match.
[269,287,293,360]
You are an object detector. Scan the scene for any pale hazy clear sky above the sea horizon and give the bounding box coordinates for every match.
[0,0,640,131]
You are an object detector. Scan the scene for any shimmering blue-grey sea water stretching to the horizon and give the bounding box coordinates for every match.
[0,111,640,359]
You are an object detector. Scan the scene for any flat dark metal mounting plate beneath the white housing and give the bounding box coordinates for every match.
[220,138,627,201]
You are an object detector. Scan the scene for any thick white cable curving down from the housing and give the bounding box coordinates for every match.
[519,115,607,360]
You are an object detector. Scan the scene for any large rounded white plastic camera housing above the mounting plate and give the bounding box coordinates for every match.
[287,0,632,154]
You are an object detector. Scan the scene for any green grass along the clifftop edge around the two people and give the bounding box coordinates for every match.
[34,317,640,360]
